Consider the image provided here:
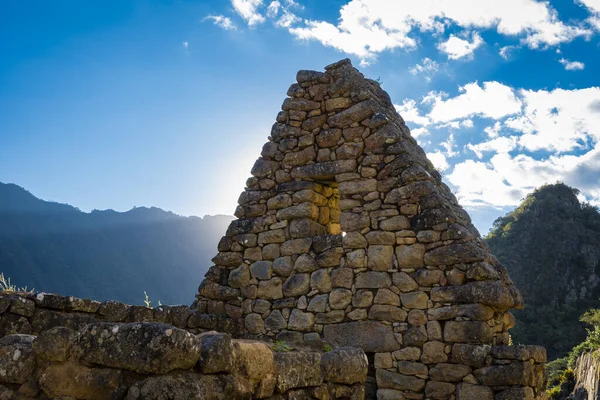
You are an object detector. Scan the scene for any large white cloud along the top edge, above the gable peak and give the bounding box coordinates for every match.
[284,0,592,63]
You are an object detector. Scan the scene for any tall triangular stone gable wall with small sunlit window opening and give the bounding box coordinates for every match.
[192,60,546,400]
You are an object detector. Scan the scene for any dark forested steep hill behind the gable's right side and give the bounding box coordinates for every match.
[486,183,600,359]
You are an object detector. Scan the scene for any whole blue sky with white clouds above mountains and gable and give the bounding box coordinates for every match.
[0,0,600,233]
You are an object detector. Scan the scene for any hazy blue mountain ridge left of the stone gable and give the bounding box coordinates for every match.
[0,183,233,304]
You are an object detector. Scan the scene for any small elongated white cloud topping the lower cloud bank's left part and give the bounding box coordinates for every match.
[428,81,521,122]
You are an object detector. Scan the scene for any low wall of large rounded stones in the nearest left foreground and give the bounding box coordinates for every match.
[0,322,368,400]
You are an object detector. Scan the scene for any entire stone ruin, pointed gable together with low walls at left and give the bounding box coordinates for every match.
[0,60,546,400]
